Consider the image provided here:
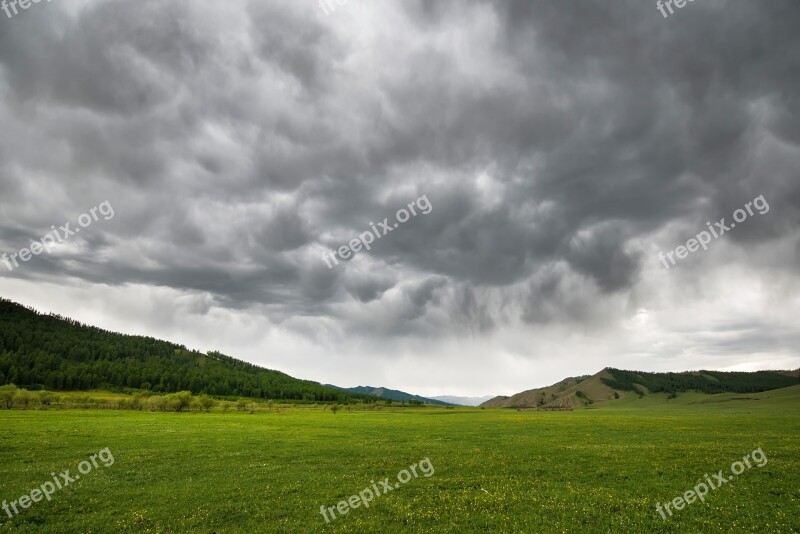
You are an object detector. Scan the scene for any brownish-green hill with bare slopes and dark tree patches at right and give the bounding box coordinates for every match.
[481,368,800,410]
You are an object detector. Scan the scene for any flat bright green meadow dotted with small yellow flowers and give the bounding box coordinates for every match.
[0,387,800,533]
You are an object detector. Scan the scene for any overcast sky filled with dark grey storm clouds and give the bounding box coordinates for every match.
[0,0,800,395]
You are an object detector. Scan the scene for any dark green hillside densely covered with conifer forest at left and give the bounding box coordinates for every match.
[0,299,367,402]
